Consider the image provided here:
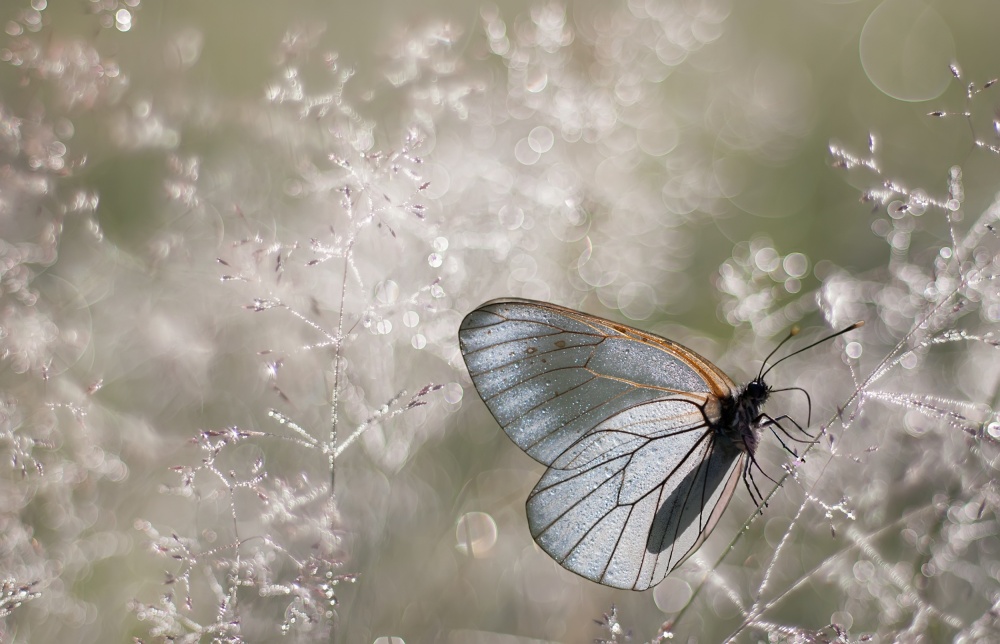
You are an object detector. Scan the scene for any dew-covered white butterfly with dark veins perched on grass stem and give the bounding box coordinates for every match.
[458,299,861,590]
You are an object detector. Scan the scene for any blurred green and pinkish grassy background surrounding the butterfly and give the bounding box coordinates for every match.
[0,0,1000,644]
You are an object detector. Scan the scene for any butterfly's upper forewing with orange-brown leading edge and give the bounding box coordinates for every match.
[459,300,735,465]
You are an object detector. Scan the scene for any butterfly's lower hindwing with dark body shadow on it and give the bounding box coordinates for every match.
[527,400,745,590]
